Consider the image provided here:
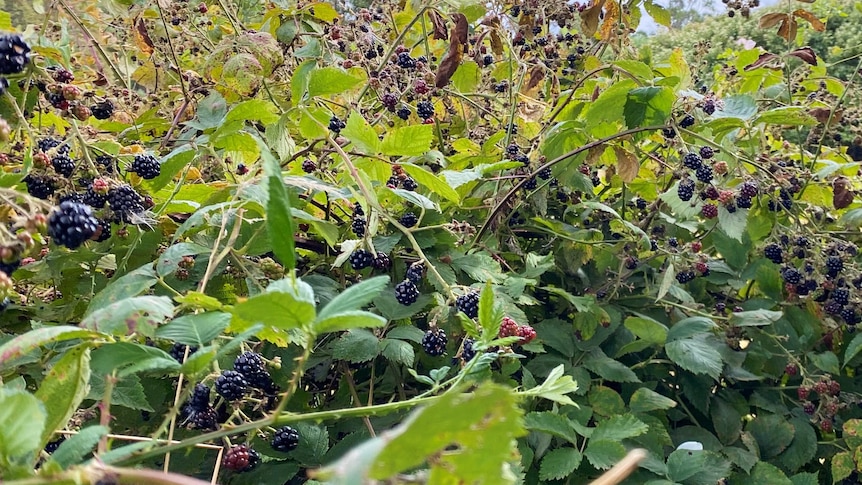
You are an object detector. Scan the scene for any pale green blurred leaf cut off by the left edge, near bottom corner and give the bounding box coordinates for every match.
[0,387,46,462]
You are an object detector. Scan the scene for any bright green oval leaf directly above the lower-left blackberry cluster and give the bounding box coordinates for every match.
[233,291,315,330]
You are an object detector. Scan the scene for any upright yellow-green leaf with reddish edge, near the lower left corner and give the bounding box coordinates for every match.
[36,344,90,446]
